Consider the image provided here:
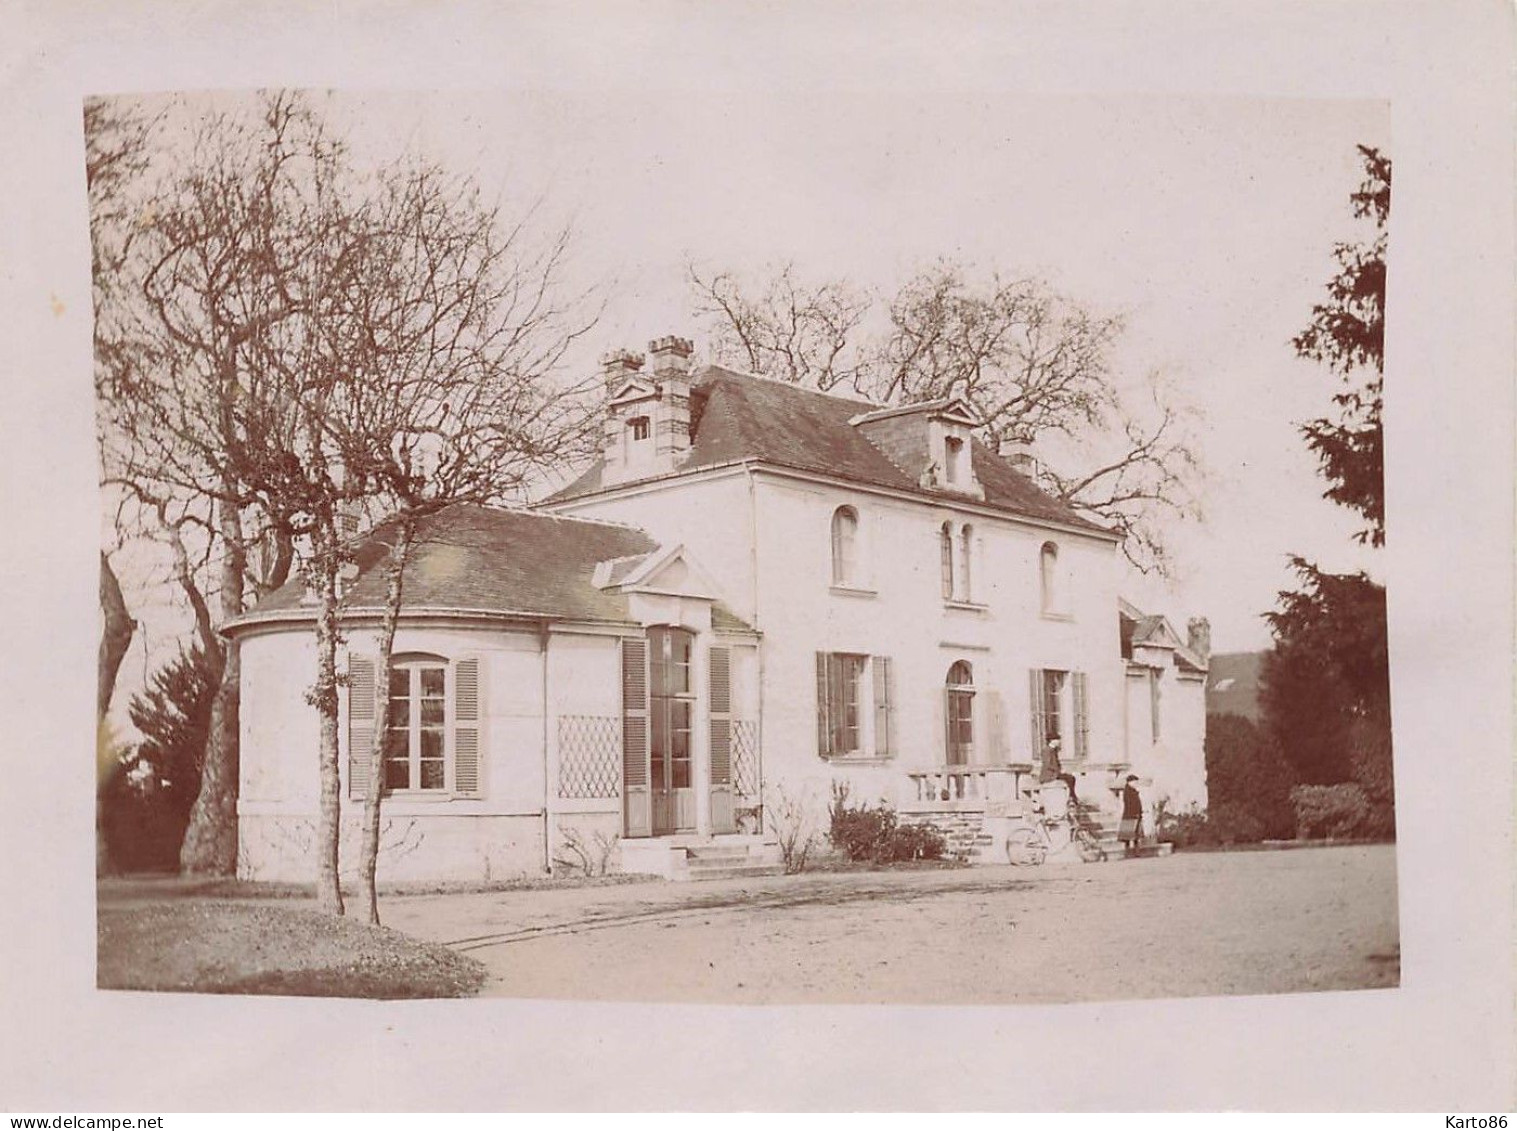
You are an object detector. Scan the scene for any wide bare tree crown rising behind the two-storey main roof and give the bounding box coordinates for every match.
[690,262,1198,570]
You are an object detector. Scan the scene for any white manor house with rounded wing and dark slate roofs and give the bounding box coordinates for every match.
[223,337,1209,881]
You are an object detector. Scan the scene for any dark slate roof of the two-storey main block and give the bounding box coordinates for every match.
[545,365,1109,534]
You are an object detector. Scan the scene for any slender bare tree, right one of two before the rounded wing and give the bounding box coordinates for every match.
[300,164,599,923]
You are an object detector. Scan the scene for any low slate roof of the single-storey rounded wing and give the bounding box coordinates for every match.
[232,505,748,629]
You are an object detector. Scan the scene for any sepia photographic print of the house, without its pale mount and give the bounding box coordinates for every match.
[82,89,1399,1004]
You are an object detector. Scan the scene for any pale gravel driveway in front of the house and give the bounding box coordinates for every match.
[381,844,1399,1004]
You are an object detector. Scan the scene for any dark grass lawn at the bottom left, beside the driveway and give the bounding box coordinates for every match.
[97,901,485,998]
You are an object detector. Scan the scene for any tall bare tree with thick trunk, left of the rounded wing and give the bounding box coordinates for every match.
[97,96,364,891]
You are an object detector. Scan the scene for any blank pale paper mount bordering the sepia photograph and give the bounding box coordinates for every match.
[0,0,1514,1111]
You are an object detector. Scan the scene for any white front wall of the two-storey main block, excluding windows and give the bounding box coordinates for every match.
[755,475,1121,804]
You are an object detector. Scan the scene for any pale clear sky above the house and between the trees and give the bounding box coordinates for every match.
[351,92,1394,650]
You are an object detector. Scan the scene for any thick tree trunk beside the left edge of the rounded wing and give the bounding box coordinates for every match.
[179,503,247,876]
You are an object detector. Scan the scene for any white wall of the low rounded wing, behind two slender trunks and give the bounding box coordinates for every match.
[238,625,620,881]
